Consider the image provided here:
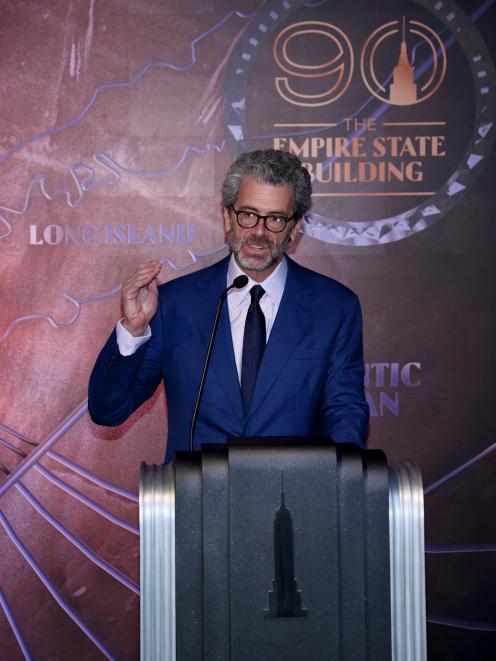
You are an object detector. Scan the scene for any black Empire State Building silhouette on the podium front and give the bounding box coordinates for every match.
[265,471,307,617]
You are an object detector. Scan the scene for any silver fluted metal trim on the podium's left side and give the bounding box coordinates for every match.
[139,463,176,661]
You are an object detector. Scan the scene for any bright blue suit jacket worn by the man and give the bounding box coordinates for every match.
[89,258,369,461]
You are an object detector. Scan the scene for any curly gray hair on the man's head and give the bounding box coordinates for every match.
[222,149,312,219]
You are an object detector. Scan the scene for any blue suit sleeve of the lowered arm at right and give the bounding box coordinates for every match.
[321,294,369,447]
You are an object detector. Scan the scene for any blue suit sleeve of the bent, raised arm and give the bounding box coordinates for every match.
[88,306,163,427]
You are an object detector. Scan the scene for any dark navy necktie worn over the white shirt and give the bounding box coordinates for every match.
[241,285,266,411]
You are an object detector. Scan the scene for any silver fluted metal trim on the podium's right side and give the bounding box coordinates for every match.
[389,462,427,661]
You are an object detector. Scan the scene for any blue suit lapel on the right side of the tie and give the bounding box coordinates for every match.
[247,258,313,416]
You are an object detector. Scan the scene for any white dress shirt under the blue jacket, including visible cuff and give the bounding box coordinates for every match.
[116,255,288,383]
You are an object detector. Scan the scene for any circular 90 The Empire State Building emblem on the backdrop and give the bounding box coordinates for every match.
[224,0,495,246]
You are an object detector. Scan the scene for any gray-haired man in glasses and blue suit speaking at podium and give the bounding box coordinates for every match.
[89,149,369,462]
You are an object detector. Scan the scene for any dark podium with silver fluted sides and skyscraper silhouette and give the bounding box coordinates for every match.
[140,438,427,661]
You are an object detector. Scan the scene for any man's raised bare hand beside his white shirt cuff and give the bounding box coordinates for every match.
[121,260,162,337]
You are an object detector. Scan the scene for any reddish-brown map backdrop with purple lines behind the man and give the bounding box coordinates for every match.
[0,0,496,661]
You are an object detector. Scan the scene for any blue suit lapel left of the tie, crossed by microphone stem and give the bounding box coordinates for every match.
[195,257,244,420]
